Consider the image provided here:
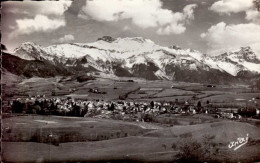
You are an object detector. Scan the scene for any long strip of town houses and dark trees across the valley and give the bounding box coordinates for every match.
[7,96,259,121]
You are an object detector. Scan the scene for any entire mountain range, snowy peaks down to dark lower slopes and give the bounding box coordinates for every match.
[2,36,260,83]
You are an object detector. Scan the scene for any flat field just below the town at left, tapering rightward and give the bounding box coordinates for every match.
[3,116,159,143]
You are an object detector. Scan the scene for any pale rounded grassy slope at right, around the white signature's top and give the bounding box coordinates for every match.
[144,121,260,143]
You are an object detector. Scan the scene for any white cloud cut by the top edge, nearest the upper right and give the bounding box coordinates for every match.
[210,0,253,14]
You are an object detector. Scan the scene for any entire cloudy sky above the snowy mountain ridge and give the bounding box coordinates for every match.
[1,0,260,56]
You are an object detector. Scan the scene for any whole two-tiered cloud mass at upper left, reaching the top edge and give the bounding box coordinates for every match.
[6,0,72,38]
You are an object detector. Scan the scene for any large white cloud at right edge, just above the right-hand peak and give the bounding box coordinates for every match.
[200,22,260,56]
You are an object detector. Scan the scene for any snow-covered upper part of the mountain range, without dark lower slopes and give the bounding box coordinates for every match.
[15,36,260,78]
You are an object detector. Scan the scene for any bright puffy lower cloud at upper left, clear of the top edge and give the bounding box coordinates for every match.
[10,15,65,37]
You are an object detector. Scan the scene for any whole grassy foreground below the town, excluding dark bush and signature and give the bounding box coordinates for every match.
[2,116,260,162]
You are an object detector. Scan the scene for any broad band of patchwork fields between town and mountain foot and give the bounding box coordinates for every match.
[3,77,260,105]
